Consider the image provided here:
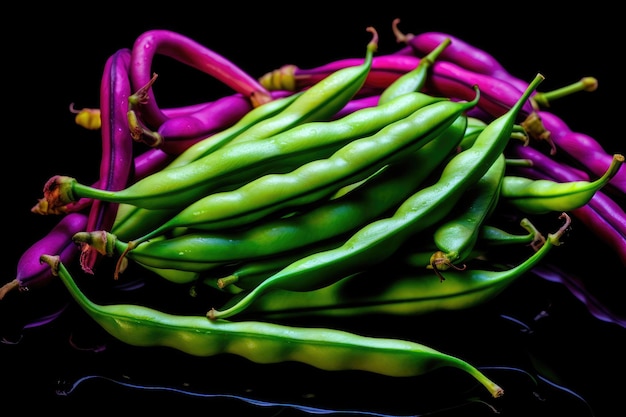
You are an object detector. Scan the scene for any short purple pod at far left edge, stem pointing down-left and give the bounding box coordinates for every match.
[0,212,88,300]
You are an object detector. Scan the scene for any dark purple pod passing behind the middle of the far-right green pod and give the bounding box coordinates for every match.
[511,146,626,265]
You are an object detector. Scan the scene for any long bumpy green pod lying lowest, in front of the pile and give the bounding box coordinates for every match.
[41,255,504,397]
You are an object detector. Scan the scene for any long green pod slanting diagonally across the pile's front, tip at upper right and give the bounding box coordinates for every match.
[207,74,544,319]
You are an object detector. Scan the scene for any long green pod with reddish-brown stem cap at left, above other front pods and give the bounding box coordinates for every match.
[45,92,443,210]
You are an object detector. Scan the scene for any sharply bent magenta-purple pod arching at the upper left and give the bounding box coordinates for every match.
[130,29,270,128]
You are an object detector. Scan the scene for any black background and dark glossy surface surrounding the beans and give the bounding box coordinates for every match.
[0,2,626,416]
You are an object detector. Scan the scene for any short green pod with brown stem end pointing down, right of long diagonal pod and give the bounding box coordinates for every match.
[429,154,506,279]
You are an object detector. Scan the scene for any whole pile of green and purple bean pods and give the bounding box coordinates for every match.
[0,21,626,404]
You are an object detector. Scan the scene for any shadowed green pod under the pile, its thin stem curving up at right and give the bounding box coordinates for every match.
[250,215,570,319]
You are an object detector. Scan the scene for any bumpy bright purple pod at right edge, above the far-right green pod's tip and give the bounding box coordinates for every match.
[538,111,626,195]
